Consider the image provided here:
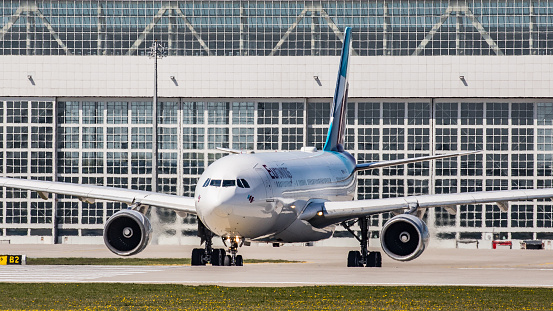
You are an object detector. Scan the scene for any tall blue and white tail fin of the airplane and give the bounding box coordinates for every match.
[323,27,351,152]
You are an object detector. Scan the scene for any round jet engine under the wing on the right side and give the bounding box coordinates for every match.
[380,214,429,261]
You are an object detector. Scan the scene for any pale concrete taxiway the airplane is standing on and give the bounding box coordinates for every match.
[0,245,553,287]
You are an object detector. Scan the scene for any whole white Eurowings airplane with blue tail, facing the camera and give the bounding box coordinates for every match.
[0,27,553,267]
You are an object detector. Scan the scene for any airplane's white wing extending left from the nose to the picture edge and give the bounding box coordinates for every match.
[0,177,196,214]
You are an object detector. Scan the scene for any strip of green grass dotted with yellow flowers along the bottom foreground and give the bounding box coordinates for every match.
[0,283,553,310]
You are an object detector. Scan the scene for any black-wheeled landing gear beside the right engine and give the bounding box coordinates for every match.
[342,217,382,267]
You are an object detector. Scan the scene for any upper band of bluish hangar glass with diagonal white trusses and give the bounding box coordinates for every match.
[0,0,553,56]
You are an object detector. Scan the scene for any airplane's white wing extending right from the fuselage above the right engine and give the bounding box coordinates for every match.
[300,188,553,227]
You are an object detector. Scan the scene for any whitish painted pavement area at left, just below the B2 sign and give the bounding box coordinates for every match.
[0,266,168,283]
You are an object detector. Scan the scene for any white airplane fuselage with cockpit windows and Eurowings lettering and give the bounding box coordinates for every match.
[194,152,356,242]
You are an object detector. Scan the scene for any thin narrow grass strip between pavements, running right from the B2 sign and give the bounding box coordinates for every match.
[27,257,298,266]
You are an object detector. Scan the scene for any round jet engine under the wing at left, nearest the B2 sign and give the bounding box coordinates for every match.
[104,210,152,256]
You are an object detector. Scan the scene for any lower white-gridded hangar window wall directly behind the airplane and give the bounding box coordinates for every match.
[0,98,553,244]
